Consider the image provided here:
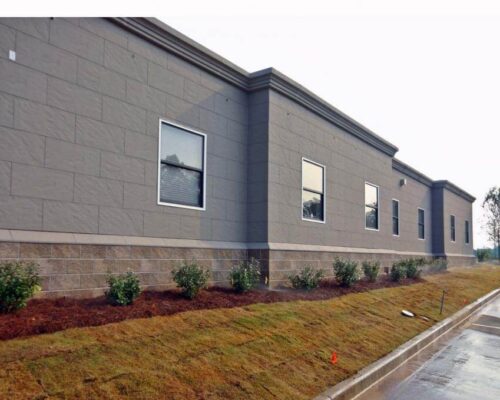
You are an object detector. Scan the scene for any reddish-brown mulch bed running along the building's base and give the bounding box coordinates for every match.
[0,276,421,340]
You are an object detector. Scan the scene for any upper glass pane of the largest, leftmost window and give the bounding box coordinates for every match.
[160,123,204,170]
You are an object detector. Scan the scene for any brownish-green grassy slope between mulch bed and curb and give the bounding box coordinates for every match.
[0,267,500,399]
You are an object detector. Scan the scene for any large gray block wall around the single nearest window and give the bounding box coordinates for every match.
[0,18,248,242]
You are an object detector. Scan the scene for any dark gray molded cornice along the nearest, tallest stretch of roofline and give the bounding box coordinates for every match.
[110,18,398,157]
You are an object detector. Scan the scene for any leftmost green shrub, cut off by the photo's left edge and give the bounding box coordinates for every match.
[0,262,41,312]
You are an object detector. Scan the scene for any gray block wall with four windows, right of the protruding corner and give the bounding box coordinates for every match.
[268,92,432,255]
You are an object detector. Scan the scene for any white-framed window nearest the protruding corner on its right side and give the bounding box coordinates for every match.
[302,158,325,222]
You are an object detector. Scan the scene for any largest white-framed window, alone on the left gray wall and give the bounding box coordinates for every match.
[158,121,206,210]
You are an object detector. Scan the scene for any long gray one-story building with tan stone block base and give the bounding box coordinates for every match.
[0,18,475,295]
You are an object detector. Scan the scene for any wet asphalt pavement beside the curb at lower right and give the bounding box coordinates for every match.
[356,298,500,400]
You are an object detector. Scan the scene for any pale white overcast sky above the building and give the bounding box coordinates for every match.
[9,0,500,247]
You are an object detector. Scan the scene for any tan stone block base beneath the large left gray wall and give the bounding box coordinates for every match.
[0,242,247,297]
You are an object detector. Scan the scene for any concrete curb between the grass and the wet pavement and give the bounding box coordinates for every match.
[314,289,500,400]
